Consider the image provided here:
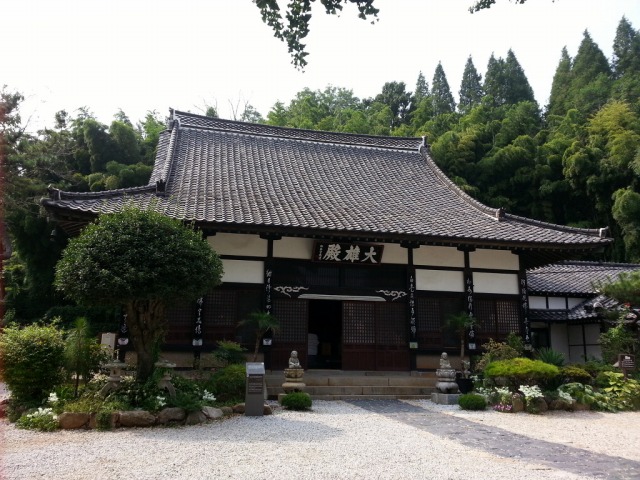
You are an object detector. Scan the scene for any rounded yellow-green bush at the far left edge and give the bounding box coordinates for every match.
[0,325,64,404]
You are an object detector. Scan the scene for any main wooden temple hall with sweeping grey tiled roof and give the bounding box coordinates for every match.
[43,111,611,371]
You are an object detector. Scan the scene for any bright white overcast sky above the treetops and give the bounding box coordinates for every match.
[5,0,640,128]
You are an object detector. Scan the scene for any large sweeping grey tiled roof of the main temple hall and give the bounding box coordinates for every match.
[43,111,611,251]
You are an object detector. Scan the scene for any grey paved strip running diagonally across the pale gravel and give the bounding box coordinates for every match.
[348,400,640,480]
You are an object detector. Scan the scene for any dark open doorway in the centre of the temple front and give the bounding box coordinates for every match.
[308,300,342,369]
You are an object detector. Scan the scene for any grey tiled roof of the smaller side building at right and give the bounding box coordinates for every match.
[527,262,640,296]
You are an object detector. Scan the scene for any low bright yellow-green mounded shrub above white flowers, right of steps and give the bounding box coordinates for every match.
[484,357,560,386]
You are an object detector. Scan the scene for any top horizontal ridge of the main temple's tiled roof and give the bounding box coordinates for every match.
[171,110,422,150]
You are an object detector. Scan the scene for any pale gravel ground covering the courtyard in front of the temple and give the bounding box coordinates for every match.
[0,401,640,480]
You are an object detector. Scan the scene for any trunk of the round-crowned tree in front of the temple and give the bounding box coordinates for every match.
[126,300,166,383]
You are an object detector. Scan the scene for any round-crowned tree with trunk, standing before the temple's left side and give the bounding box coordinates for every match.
[55,207,222,381]
